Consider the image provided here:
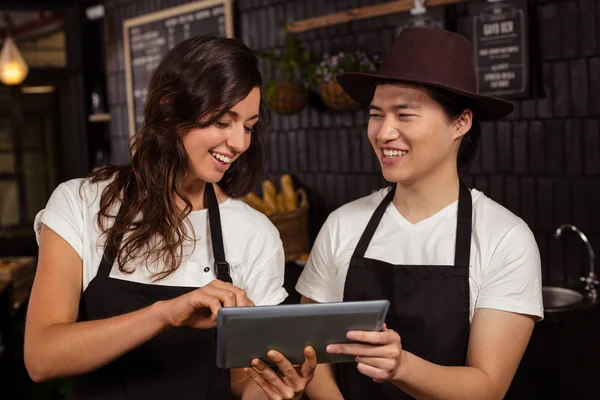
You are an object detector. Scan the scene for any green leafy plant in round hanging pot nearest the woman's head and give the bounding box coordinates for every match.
[255,31,315,115]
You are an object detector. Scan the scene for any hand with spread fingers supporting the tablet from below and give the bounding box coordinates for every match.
[244,346,317,400]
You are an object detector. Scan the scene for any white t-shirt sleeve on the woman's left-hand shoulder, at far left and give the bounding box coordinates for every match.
[34,179,84,258]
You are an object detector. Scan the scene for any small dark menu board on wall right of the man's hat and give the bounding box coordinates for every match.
[470,0,530,99]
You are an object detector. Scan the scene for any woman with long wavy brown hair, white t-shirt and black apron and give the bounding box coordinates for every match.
[25,35,316,399]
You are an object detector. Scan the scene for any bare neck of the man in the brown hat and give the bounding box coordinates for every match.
[393,163,459,224]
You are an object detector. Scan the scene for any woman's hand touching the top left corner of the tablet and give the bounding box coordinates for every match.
[160,280,254,329]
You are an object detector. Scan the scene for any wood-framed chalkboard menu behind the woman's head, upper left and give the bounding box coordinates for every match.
[123,0,233,137]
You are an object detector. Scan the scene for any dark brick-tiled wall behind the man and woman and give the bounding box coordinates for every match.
[105,0,600,284]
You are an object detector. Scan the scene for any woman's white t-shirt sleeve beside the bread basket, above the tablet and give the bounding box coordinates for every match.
[243,217,288,306]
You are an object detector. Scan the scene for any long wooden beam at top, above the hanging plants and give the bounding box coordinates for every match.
[287,0,465,33]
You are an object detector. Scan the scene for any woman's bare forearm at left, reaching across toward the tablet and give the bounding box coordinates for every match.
[25,302,168,381]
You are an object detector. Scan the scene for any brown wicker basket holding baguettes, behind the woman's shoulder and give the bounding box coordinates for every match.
[269,189,310,262]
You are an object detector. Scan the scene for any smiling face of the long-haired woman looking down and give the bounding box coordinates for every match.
[182,88,260,182]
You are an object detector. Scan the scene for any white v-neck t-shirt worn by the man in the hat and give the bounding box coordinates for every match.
[296,188,544,320]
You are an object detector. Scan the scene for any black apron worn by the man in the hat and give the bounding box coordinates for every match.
[338,182,472,400]
